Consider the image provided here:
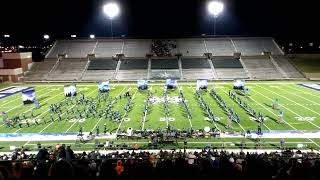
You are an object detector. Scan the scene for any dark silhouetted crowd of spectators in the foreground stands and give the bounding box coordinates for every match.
[0,145,320,180]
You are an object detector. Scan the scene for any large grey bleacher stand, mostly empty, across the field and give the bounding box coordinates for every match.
[25,38,305,81]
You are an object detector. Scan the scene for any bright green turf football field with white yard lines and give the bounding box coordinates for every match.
[0,81,320,152]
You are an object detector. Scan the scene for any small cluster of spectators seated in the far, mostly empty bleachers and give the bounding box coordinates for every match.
[151,40,177,57]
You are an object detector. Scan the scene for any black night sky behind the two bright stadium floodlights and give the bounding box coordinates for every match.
[0,0,320,39]
